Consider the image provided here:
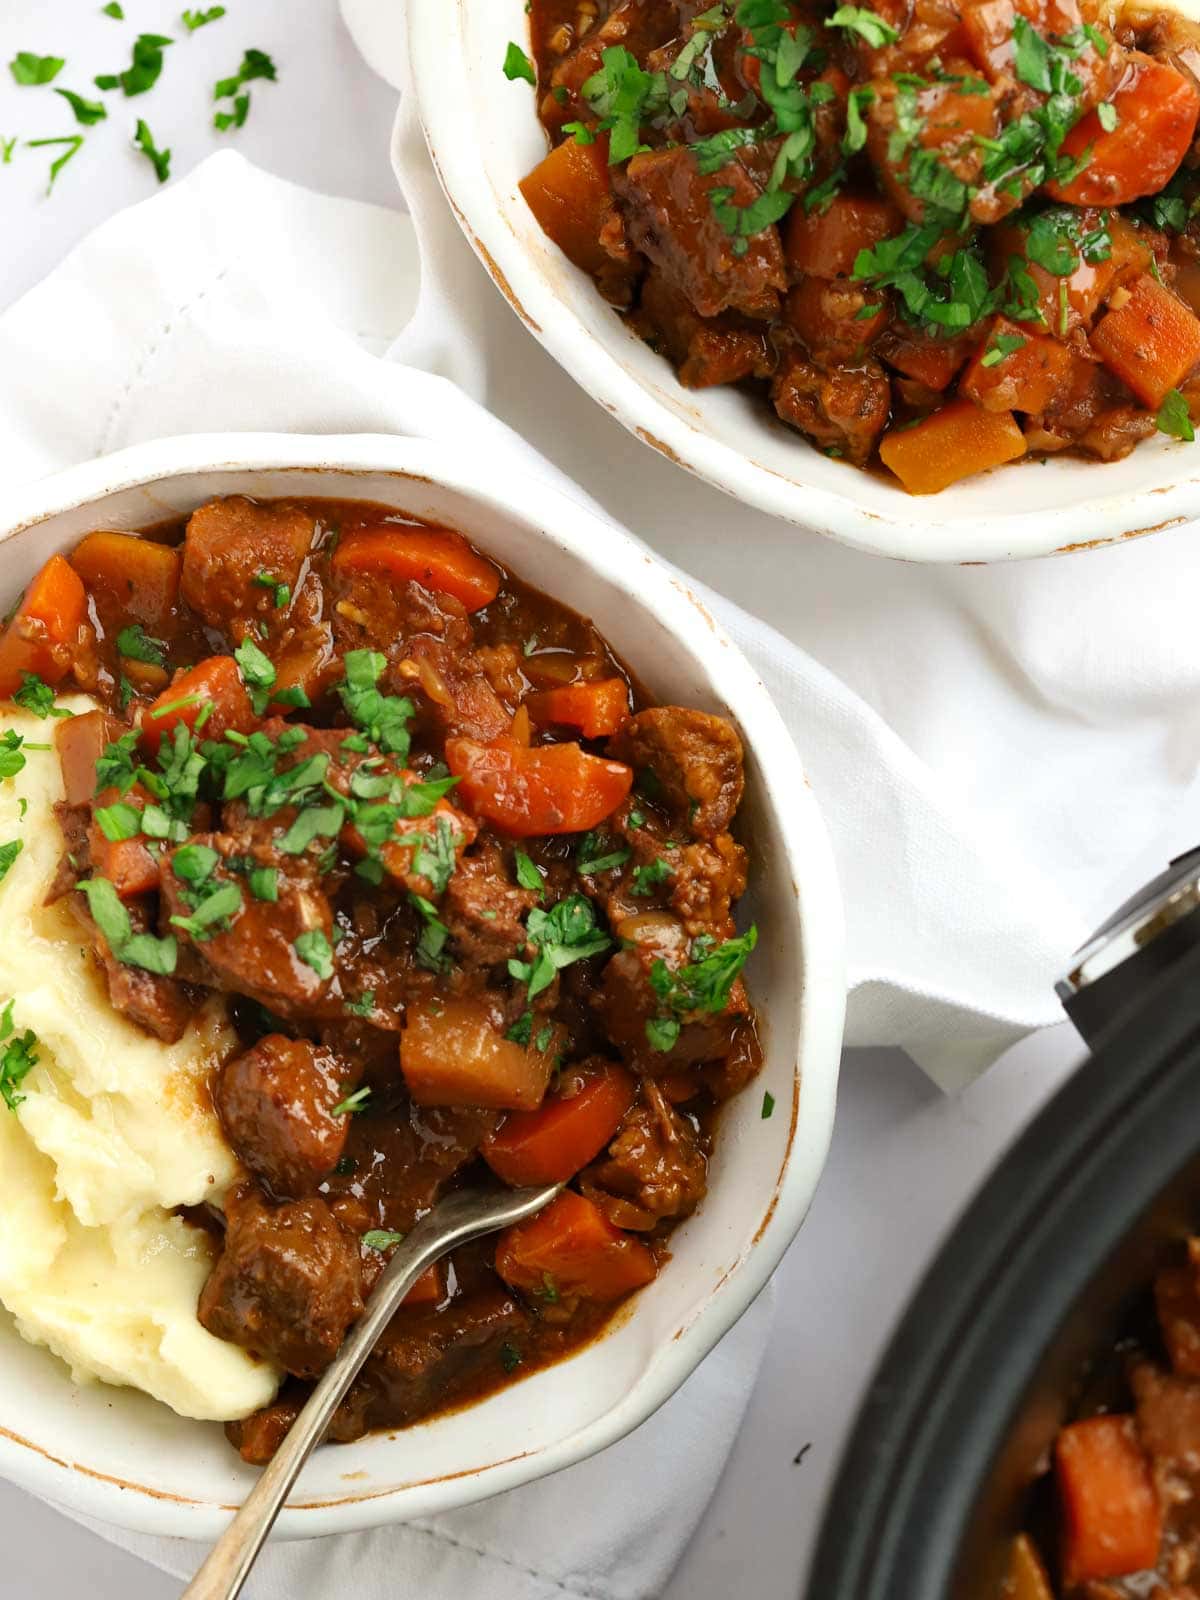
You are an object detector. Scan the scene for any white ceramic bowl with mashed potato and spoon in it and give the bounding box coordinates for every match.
[0,434,845,1539]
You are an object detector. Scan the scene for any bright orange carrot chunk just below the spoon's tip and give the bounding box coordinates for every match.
[496,1189,658,1301]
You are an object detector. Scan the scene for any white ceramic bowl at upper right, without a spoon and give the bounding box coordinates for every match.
[408,0,1200,562]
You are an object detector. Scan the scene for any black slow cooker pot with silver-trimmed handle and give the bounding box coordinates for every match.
[805,850,1200,1600]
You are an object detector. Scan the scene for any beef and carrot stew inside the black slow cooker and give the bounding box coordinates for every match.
[1005,1238,1200,1600]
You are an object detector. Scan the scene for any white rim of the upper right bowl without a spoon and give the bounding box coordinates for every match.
[402,0,1200,565]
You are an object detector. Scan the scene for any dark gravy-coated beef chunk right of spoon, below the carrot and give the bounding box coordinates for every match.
[330,1288,528,1440]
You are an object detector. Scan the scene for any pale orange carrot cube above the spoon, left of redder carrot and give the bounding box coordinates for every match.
[400,1000,562,1110]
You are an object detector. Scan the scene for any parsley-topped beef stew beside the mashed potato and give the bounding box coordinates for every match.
[0,496,762,1461]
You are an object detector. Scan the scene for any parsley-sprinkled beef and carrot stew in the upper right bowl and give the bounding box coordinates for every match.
[506,0,1200,493]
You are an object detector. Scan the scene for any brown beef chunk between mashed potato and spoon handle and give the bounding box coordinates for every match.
[197,1184,363,1378]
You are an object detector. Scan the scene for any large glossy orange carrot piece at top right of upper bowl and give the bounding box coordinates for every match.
[1046,50,1200,206]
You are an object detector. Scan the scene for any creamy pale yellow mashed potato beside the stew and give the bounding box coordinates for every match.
[0,698,278,1421]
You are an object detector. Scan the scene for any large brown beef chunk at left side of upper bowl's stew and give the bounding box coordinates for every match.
[616,146,787,317]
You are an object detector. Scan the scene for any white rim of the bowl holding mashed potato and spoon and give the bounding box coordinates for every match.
[0,434,846,1539]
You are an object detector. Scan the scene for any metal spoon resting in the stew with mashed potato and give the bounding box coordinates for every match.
[182,1184,562,1600]
